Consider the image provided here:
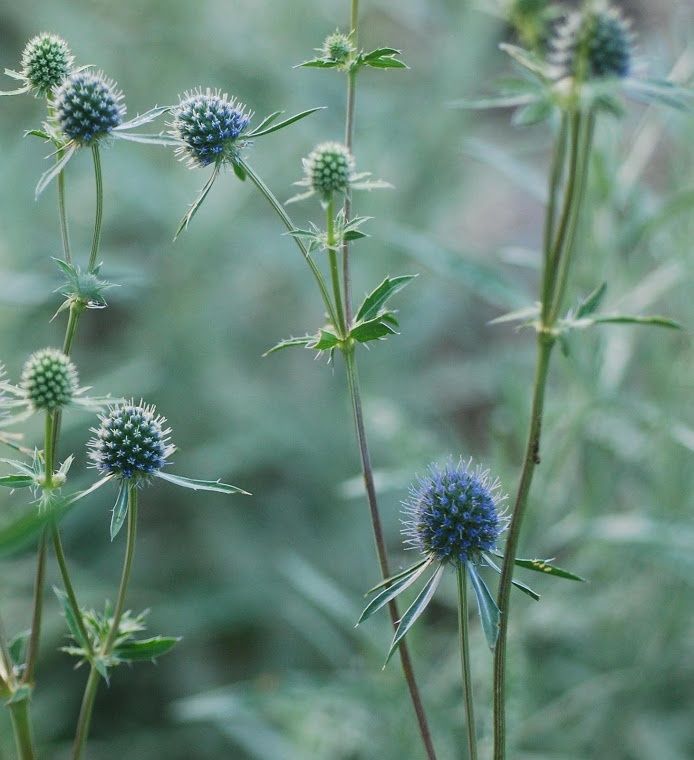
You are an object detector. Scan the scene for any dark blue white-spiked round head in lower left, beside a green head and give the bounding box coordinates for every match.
[88,401,175,481]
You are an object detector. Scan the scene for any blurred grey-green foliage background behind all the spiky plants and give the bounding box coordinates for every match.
[0,0,694,760]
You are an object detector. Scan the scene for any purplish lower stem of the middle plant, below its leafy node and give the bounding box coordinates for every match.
[343,346,436,760]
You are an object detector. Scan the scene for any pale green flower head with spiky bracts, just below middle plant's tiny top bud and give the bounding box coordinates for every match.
[287,142,392,204]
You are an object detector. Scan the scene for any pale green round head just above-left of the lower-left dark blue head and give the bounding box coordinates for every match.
[20,348,79,412]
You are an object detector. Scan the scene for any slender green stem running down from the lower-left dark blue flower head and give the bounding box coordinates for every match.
[72,485,137,760]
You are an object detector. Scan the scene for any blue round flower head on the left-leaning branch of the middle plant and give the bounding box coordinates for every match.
[171,88,251,168]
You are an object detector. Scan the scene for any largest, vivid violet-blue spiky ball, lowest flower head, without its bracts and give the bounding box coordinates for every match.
[403,460,506,563]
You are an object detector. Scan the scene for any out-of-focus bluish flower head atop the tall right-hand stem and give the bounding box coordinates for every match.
[551,4,634,79]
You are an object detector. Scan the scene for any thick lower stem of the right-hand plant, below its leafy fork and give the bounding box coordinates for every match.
[494,332,554,760]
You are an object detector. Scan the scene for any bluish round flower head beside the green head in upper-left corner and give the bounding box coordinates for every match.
[54,71,125,145]
